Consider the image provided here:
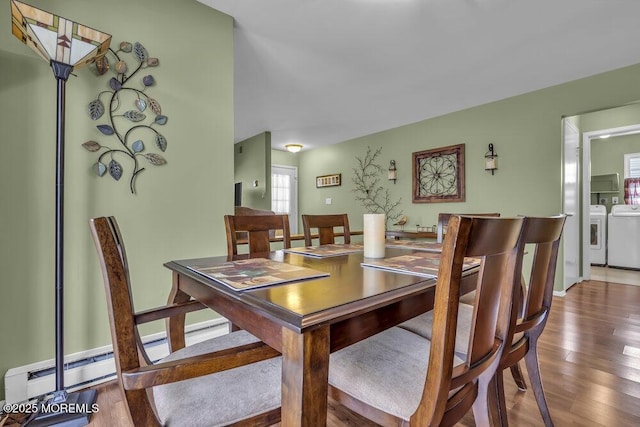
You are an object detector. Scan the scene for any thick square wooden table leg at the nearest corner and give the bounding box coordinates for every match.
[282,326,330,427]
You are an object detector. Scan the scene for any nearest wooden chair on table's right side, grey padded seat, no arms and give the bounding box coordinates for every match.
[329,216,524,426]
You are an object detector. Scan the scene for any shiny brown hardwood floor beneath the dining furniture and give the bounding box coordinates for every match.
[0,281,640,427]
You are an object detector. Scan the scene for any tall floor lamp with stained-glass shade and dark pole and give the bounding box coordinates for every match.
[11,0,111,427]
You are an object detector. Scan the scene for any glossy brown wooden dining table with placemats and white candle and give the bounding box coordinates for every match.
[165,247,477,426]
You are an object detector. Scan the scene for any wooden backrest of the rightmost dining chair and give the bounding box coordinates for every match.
[503,215,566,352]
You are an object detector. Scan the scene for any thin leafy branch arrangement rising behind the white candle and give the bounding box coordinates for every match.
[352,147,403,228]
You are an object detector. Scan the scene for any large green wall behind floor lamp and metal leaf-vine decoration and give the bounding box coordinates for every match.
[0,0,234,400]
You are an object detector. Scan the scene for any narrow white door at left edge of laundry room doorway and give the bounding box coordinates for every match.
[562,119,580,290]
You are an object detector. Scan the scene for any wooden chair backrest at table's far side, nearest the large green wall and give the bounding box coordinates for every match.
[224,214,291,257]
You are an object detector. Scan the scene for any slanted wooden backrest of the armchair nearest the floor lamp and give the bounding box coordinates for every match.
[90,217,155,419]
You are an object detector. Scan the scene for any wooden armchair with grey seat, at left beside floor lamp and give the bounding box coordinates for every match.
[90,217,282,427]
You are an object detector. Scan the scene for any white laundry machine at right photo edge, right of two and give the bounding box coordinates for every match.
[607,205,640,269]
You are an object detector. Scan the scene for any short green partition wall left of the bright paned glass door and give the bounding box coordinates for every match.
[233,132,271,210]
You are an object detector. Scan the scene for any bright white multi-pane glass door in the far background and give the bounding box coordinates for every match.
[271,165,298,234]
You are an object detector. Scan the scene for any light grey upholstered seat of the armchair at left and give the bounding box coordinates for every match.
[153,331,282,427]
